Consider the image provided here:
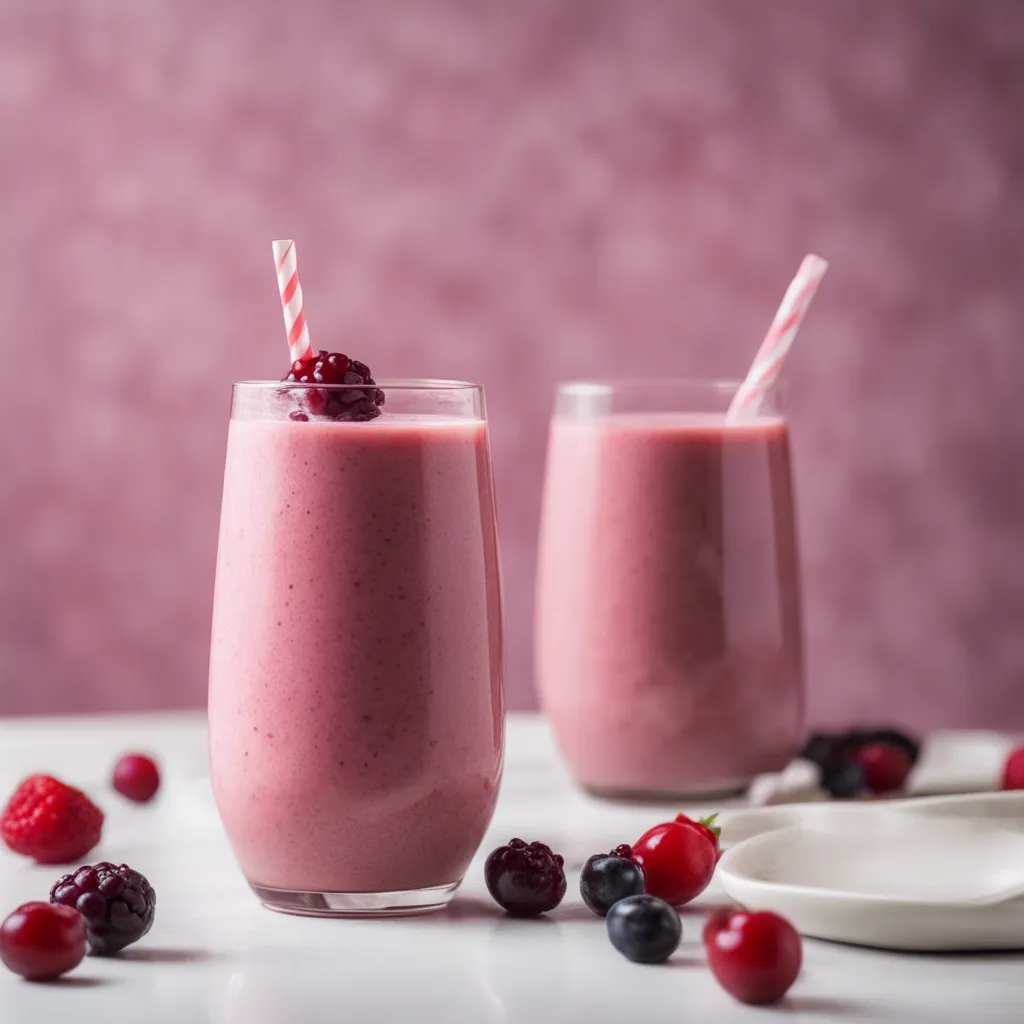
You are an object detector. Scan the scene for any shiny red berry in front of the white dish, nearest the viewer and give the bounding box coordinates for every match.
[703,910,804,1005]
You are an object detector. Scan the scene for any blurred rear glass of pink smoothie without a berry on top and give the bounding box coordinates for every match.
[536,381,804,797]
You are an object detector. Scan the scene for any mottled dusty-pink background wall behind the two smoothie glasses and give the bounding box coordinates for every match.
[0,0,1024,727]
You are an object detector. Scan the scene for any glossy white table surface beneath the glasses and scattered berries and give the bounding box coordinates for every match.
[0,714,1024,1024]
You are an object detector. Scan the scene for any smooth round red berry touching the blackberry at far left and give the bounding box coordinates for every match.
[0,903,85,981]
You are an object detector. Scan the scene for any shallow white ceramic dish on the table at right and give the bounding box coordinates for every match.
[718,793,1024,950]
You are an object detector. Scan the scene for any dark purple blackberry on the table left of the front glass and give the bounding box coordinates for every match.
[50,861,157,954]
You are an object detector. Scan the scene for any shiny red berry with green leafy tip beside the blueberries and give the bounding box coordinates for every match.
[633,819,719,906]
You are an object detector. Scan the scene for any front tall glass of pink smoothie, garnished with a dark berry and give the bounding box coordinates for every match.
[210,381,504,915]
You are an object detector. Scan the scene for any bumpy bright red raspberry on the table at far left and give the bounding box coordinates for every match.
[0,775,103,864]
